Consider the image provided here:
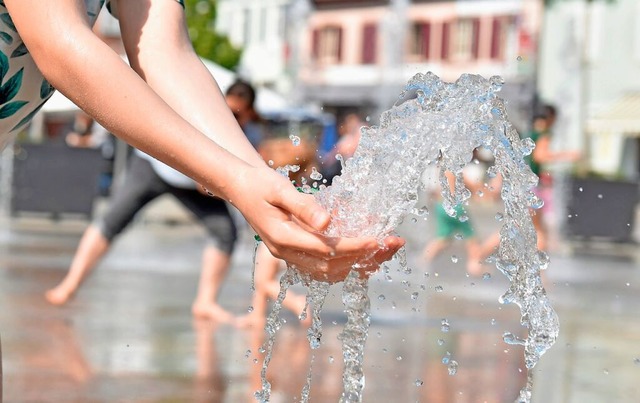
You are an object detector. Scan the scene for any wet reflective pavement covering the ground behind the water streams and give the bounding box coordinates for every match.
[0,202,640,403]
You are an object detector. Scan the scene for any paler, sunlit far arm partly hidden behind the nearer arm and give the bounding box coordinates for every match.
[118,1,264,166]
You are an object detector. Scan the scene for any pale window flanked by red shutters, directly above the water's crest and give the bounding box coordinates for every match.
[442,18,480,61]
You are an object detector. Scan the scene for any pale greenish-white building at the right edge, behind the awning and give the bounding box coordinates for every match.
[539,0,640,179]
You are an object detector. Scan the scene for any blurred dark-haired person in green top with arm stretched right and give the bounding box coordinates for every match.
[527,104,581,251]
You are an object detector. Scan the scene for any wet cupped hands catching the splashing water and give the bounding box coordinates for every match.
[227,167,404,283]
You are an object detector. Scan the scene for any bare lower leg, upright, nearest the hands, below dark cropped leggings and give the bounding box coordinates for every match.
[191,246,233,322]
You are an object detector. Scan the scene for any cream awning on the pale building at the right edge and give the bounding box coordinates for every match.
[587,92,640,136]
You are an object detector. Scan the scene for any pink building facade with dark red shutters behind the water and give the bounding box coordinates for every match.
[298,0,542,126]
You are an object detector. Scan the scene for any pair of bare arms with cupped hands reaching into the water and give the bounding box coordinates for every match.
[5,0,403,280]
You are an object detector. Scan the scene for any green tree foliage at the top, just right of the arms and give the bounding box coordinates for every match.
[185,0,242,69]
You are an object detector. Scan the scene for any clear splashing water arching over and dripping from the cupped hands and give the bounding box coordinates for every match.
[257,73,559,402]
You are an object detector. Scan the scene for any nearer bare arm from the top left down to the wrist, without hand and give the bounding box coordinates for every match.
[7,0,248,199]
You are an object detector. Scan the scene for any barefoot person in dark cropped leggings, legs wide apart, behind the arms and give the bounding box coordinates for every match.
[45,81,262,323]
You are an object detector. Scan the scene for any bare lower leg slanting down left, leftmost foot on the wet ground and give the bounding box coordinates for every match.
[45,225,110,305]
